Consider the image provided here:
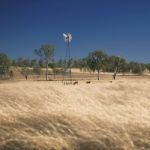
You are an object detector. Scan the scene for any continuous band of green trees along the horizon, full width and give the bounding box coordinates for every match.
[0,46,150,78]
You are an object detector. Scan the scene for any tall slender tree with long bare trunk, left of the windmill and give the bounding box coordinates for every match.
[34,44,55,80]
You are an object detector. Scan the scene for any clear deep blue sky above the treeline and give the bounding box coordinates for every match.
[0,0,150,63]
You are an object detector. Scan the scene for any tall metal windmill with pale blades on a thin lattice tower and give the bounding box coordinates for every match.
[63,33,72,81]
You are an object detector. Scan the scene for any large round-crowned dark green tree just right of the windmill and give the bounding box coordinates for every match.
[87,50,107,80]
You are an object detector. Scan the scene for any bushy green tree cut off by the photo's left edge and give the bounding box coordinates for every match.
[0,53,11,78]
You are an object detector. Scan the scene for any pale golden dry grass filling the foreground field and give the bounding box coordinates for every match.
[0,78,150,150]
